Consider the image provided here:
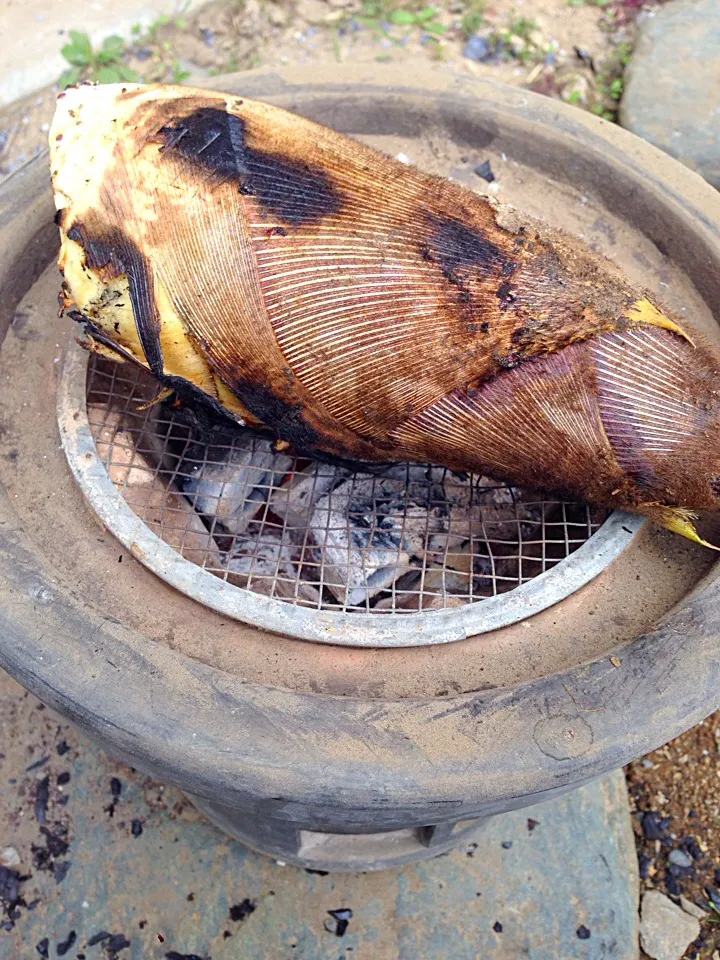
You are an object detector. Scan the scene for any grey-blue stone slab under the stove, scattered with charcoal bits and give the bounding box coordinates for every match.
[0,674,638,960]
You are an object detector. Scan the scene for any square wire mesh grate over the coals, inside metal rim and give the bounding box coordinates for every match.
[87,355,607,614]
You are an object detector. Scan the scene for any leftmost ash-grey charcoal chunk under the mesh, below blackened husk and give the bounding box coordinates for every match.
[177,433,293,536]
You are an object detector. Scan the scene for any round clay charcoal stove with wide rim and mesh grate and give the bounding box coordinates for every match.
[0,65,720,870]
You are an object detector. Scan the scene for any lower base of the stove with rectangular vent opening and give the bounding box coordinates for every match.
[187,794,491,873]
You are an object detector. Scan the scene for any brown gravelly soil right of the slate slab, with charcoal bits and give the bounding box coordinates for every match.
[627,711,720,960]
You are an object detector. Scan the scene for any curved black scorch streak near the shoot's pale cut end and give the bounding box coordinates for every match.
[67,222,163,377]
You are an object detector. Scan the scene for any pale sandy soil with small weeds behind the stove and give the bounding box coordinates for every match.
[0,0,662,177]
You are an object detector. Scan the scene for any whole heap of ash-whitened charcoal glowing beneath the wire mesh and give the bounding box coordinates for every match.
[181,436,556,610]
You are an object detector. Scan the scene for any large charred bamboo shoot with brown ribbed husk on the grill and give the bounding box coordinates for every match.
[50,84,720,542]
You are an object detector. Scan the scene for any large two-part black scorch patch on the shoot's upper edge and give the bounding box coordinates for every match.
[155,107,341,226]
